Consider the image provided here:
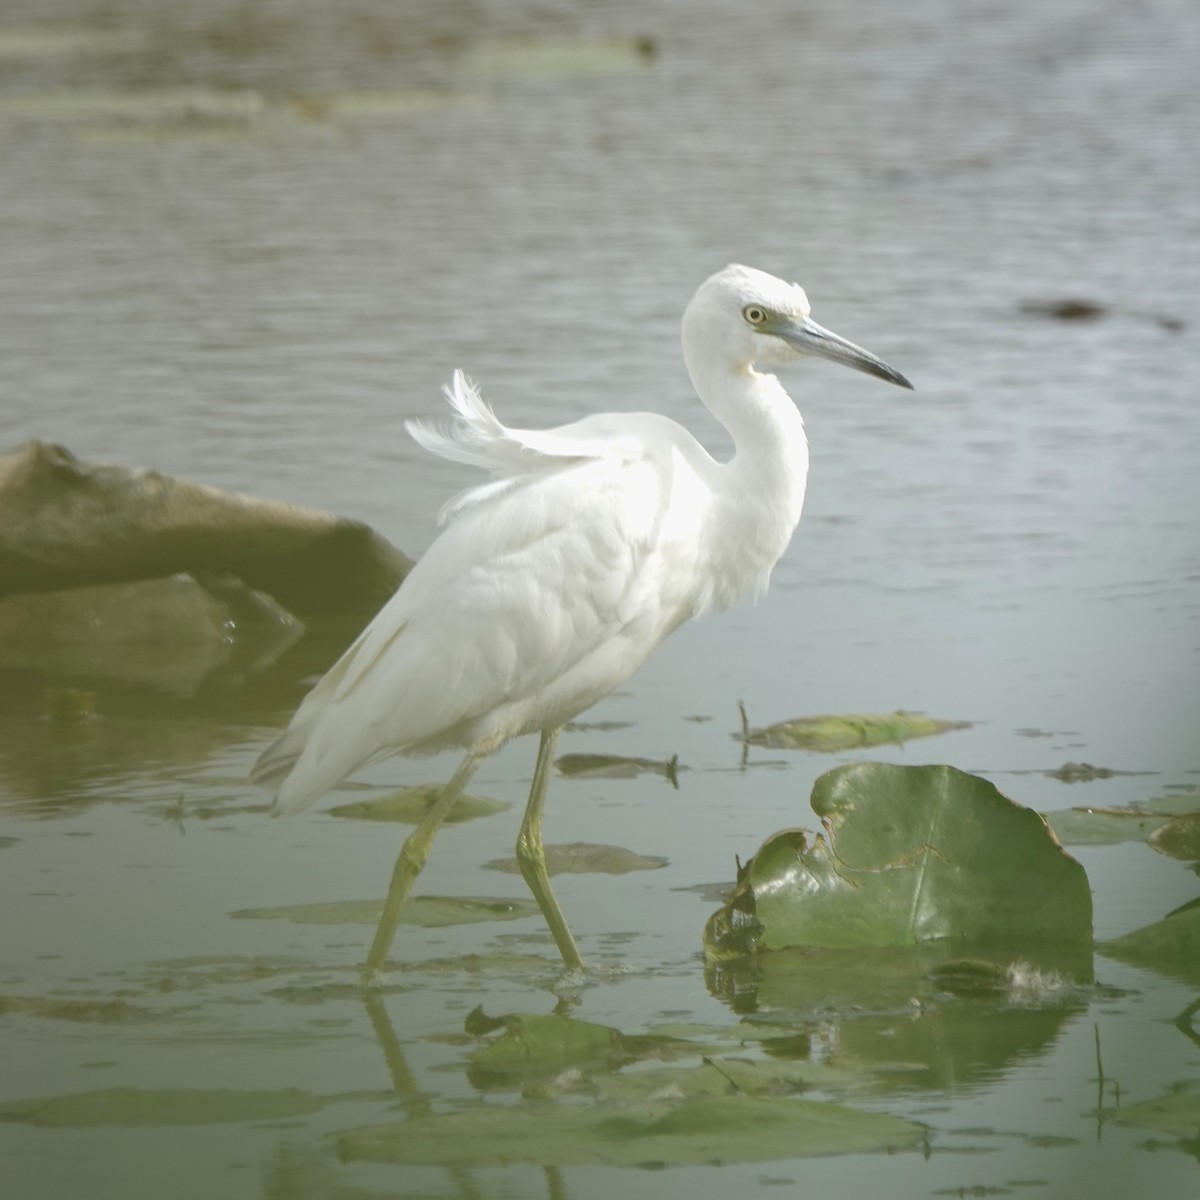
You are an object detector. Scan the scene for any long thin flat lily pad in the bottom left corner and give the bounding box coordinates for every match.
[0,1087,332,1129]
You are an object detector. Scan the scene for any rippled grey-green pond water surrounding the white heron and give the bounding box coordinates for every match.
[0,0,1200,1200]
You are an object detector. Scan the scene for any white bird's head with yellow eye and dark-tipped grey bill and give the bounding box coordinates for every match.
[684,263,912,388]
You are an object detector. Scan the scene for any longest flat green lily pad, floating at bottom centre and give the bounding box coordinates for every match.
[338,1092,925,1166]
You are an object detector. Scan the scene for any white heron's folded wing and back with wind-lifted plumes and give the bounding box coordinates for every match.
[254,403,712,811]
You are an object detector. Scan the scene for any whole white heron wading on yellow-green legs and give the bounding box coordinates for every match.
[252,265,912,978]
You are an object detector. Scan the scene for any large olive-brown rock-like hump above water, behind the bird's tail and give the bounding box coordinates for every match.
[0,442,412,629]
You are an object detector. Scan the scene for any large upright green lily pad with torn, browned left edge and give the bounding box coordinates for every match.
[704,763,1092,959]
